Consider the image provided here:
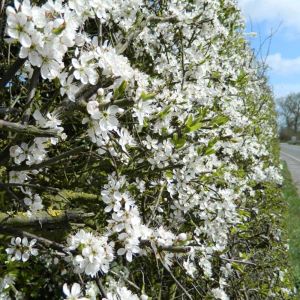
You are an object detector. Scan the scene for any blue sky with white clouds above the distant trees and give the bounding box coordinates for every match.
[237,0,300,97]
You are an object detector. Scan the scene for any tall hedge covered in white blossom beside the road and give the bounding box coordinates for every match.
[0,0,291,300]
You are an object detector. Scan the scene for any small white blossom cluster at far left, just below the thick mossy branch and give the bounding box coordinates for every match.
[6,237,38,262]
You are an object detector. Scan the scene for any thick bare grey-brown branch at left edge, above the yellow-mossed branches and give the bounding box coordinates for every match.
[0,120,59,137]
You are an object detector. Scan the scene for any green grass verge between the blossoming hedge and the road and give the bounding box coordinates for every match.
[283,162,300,291]
